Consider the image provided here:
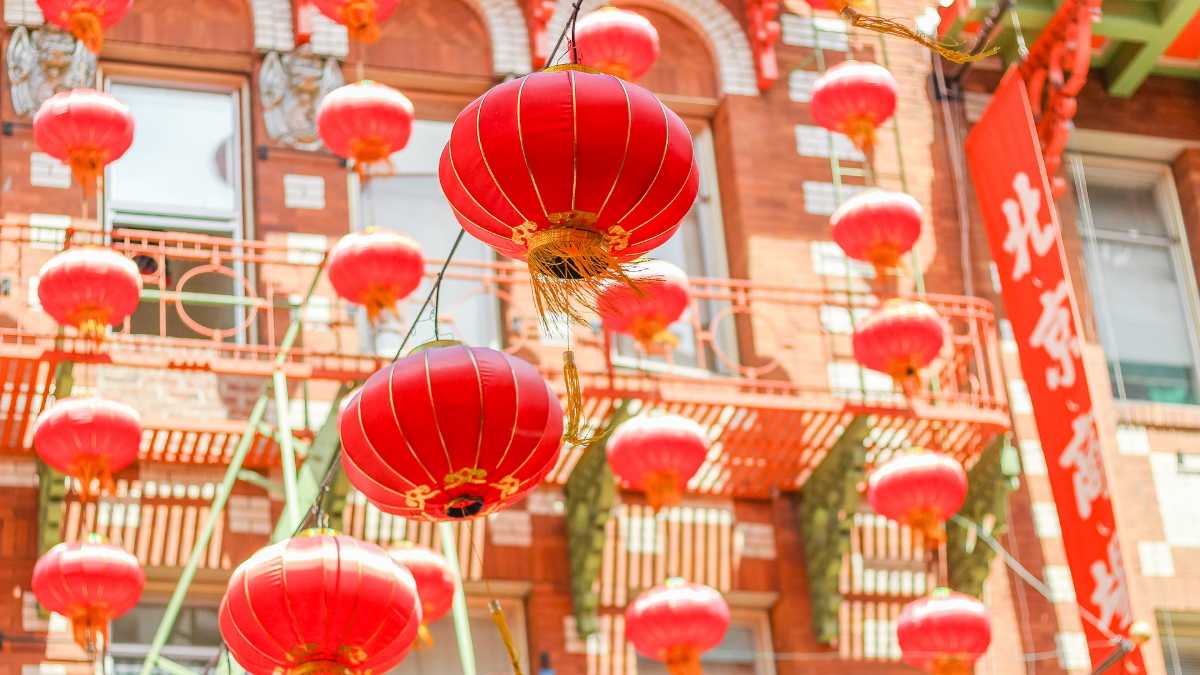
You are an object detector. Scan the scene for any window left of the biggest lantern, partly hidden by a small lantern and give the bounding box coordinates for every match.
[359,120,499,356]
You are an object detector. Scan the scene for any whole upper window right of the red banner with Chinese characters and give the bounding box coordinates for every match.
[1072,157,1200,404]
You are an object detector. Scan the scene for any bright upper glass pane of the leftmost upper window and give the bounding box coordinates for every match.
[108,83,240,217]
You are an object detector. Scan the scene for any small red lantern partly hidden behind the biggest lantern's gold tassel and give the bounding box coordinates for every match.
[596,261,691,352]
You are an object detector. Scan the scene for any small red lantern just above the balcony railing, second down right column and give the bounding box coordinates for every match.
[829,190,922,277]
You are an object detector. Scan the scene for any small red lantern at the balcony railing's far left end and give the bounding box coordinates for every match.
[37,249,142,340]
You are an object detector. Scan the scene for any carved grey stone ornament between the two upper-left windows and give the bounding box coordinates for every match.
[258,46,346,150]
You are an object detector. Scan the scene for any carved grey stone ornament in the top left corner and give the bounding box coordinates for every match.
[5,26,96,117]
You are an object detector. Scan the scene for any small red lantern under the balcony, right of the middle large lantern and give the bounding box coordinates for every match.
[607,414,708,510]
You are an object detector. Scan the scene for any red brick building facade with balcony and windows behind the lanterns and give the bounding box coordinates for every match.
[0,0,1200,675]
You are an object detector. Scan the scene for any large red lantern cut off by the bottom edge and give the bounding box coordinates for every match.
[217,530,421,675]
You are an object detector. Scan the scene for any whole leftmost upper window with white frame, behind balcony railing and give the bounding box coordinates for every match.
[104,77,246,338]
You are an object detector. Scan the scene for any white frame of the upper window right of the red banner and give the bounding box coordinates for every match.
[1067,153,1200,405]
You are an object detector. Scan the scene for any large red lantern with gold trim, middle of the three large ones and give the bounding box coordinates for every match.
[338,344,563,520]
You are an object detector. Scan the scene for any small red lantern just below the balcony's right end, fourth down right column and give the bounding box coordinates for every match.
[866,449,967,548]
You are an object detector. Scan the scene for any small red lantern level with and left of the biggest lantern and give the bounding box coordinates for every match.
[317,79,415,177]
